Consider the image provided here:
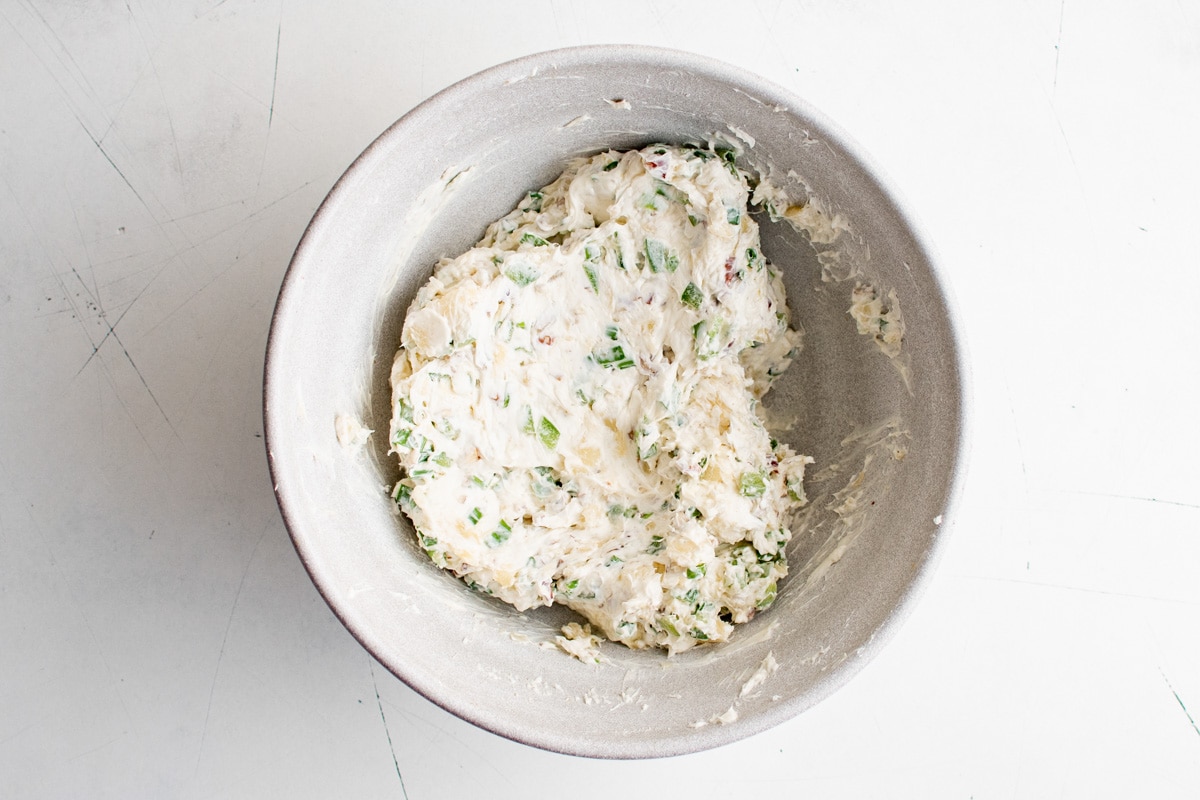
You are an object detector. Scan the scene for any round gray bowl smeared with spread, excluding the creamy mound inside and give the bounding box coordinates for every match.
[264,47,965,758]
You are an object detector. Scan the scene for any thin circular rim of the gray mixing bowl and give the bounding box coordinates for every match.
[263,44,973,759]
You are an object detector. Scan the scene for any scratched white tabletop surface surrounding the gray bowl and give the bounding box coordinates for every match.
[0,0,1200,800]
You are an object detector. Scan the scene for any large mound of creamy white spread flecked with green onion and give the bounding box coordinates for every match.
[390,145,811,652]
